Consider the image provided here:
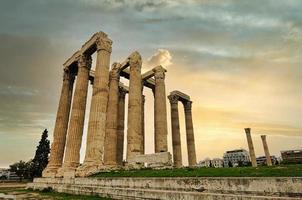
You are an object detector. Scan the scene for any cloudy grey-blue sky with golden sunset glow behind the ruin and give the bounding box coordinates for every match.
[0,0,302,167]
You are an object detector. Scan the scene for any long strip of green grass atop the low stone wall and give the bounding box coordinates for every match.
[92,164,302,177]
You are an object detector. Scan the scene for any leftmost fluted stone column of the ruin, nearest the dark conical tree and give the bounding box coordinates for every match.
[43,69,75,177]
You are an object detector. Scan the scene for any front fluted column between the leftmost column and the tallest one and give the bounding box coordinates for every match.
[58,55,91,177]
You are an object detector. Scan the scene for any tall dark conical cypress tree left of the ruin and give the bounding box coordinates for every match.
[30,129,50,178]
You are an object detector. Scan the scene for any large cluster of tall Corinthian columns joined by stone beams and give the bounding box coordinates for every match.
[43,32,196,177]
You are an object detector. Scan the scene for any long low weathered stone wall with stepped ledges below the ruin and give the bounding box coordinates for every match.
[28,177,302,200]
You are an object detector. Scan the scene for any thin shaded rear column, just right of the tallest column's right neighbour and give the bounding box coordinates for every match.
[116,87,128,166]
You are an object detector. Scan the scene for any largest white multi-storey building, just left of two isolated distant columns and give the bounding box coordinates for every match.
[223,149,250,167]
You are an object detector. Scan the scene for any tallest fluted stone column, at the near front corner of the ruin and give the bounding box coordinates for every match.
[78,37,112,173]
